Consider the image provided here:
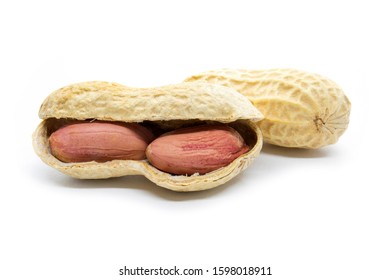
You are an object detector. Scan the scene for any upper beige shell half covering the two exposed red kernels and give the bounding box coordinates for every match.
[39,81,263,123]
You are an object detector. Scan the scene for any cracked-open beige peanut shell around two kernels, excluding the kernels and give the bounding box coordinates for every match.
[33,82,263,191]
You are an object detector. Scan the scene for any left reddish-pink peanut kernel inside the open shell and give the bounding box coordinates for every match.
[49,122,153,162]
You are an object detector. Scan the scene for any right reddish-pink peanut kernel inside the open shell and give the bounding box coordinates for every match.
[146,125,249,175]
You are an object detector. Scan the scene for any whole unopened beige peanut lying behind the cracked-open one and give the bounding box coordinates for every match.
[186,69,351,149]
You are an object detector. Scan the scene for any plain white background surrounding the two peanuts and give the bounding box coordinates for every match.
[0,0,390,280]
